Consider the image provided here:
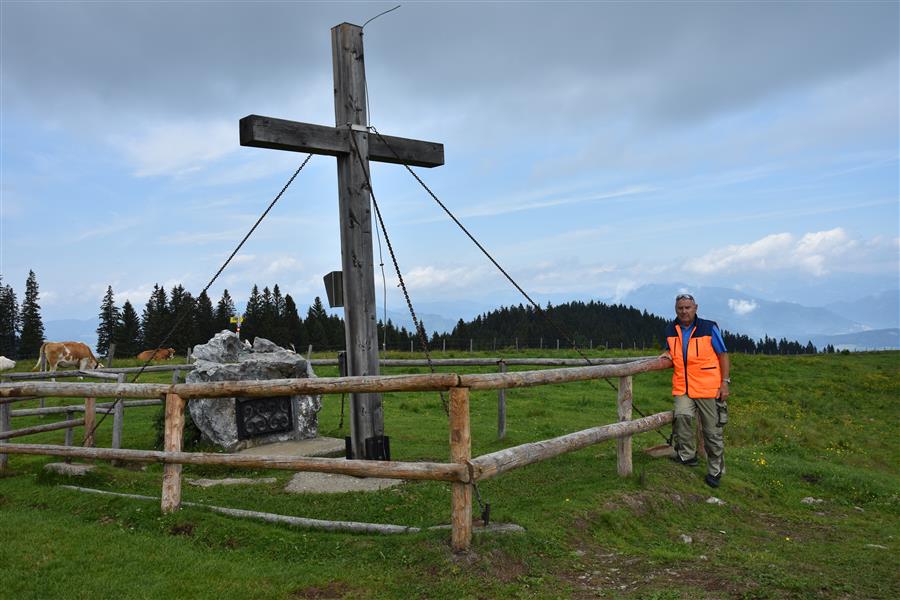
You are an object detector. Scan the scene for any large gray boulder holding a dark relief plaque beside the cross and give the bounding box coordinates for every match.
[185,331,322,452]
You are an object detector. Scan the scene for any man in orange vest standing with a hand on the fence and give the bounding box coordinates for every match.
[663,294,731,488]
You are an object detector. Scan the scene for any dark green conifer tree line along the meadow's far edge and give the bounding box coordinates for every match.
[0,271,835,358]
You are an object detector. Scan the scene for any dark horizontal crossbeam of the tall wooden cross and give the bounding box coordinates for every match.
[240,115,444,168]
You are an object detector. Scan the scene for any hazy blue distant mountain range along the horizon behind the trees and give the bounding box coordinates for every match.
[44,283,900,350]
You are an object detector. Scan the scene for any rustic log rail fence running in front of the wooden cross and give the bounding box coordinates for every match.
[0,357,672,551]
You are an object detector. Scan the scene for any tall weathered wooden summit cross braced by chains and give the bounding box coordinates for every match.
[240,23,444,460]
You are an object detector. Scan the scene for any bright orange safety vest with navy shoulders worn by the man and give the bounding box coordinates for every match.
[666,319,722,398]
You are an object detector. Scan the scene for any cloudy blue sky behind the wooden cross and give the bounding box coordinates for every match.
[0,0,900,328]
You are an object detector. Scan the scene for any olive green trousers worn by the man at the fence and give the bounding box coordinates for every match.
[672,395,725,477]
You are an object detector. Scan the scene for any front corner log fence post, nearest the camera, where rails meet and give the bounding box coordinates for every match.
[450,387,472,552]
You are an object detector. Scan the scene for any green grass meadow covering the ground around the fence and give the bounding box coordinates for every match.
[0,351,900,600]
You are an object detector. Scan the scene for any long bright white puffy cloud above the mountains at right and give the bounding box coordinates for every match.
[686,227,857,276]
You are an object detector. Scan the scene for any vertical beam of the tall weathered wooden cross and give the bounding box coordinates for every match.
[331,23,384,458]
